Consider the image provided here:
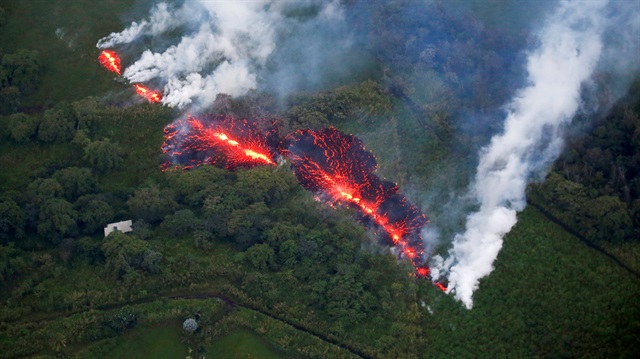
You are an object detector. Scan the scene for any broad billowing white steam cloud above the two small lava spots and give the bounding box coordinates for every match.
[97,0,348,108]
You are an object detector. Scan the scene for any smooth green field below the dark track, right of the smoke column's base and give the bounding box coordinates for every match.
[425,208,640,358]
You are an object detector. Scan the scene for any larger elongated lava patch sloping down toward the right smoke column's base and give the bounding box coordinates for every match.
[282,128,428,276]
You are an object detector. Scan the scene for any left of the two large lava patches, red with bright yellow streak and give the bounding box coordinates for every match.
[162,115,277,170]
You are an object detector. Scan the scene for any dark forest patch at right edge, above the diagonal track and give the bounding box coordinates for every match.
[532,83,640,243]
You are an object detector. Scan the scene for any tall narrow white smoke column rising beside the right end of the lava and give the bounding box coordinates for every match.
[433,0,606,309]
